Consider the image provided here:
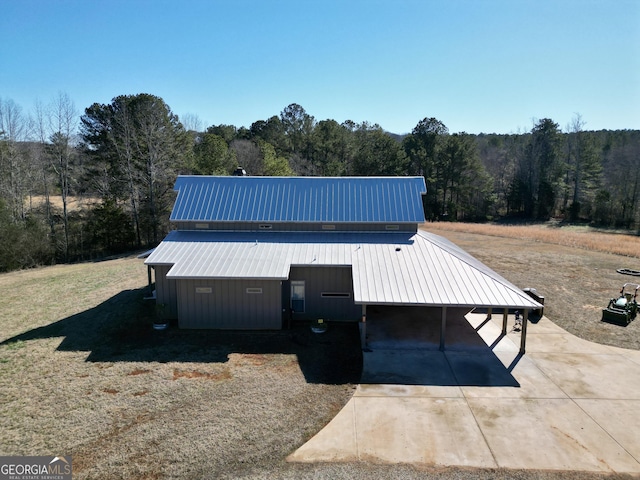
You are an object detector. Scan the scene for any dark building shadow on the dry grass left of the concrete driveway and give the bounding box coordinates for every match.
[0,288,362,384]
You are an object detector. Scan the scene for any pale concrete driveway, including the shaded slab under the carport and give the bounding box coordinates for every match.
[289,309,640,475]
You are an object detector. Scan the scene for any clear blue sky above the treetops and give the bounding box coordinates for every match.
[0,0,640,133]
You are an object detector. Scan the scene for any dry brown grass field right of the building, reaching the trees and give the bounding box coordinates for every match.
[423,223,640,350]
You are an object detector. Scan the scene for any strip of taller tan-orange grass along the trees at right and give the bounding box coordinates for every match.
[423,222,640,258]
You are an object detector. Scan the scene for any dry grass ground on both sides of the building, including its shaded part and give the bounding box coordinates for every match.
[0,229,640,480]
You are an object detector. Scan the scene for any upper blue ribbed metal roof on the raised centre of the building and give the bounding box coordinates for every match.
[171,176,427,223]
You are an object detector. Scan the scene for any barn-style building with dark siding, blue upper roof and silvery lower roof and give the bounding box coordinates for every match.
[145,176,540,347]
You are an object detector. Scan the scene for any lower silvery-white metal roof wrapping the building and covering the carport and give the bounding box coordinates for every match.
[145,231,541,308]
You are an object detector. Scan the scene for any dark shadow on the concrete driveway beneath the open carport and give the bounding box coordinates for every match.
[360,307,521,387]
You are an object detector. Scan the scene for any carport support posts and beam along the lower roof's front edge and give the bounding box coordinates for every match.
[356,302,542,355]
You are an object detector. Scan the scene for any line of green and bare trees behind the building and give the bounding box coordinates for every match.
[0,93,640,271]
